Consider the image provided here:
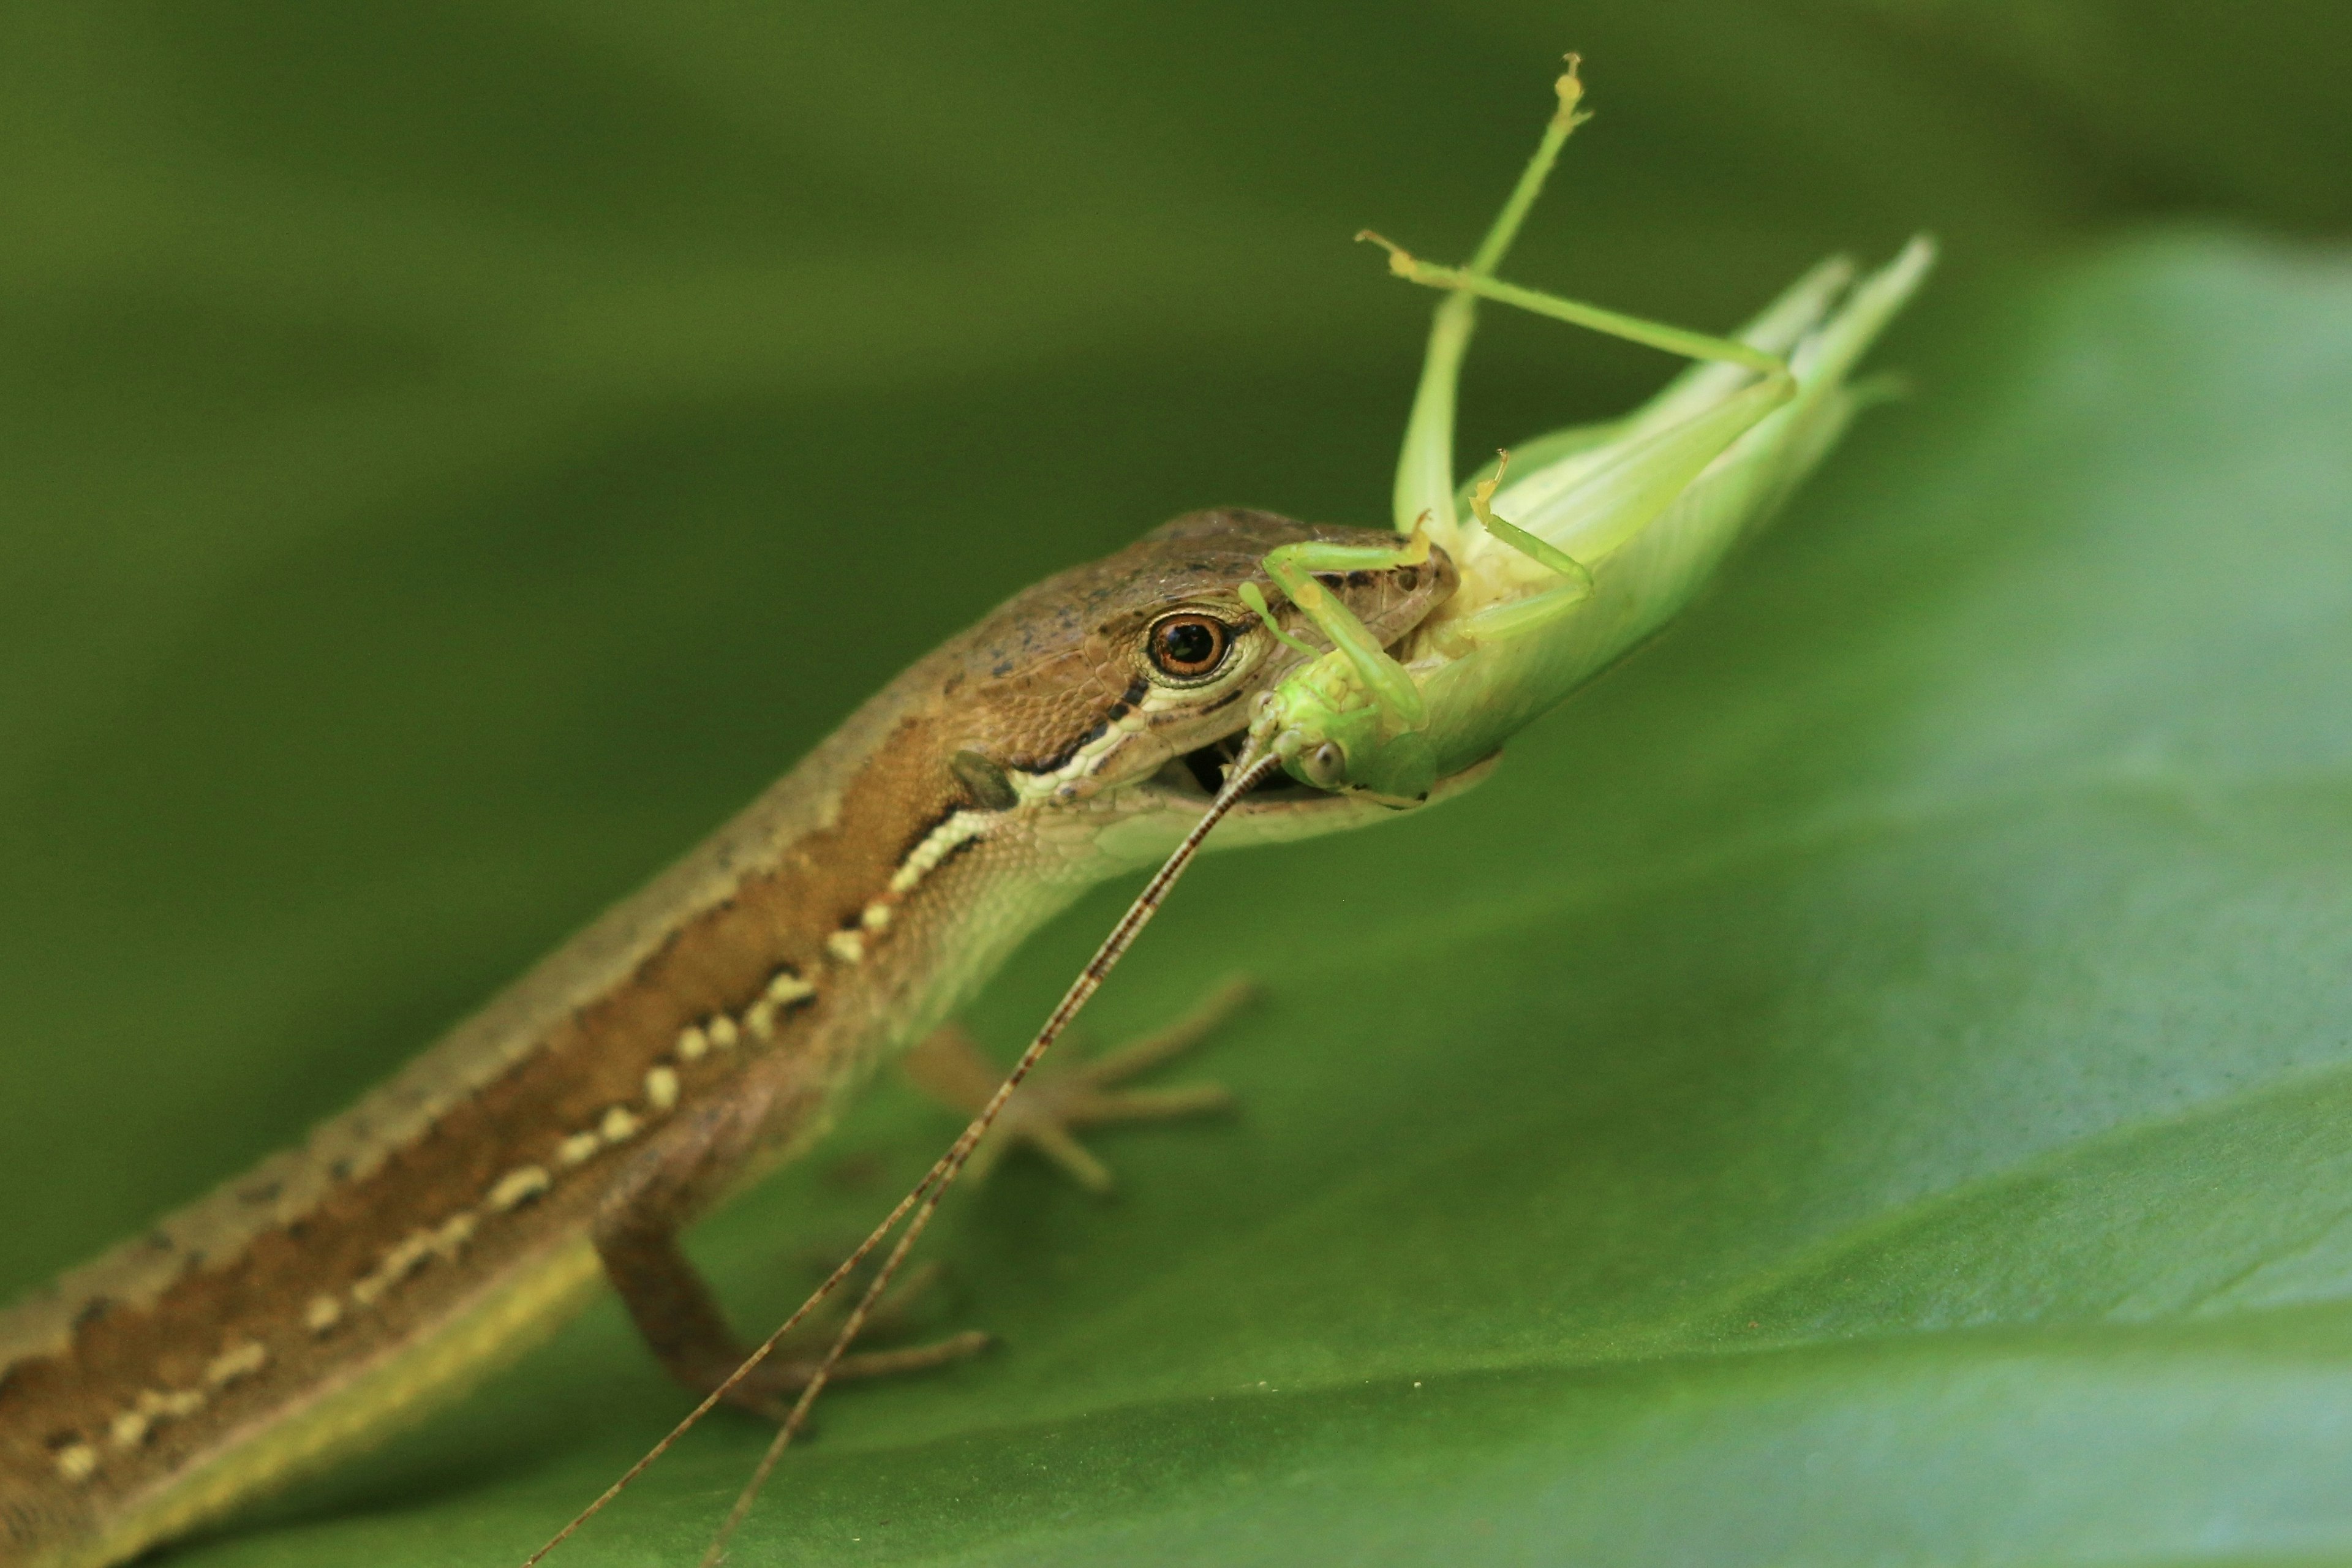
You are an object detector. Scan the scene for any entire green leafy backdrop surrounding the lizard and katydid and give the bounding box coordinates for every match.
[0,0,2352,1568]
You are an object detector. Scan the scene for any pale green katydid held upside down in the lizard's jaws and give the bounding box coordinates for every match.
[1249,56,1933,804]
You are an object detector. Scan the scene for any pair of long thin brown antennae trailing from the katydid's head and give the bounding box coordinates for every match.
[522,750,1282,1568]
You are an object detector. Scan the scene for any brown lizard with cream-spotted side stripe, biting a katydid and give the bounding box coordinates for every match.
[0,510,1468,1568]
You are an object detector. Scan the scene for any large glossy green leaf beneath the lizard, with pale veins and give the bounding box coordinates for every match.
[147,239,2352,1563]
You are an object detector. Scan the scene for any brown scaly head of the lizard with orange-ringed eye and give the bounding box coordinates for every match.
[943,510,1456,809]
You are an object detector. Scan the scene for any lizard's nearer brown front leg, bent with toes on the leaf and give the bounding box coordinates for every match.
[593,1096,988,1420]
